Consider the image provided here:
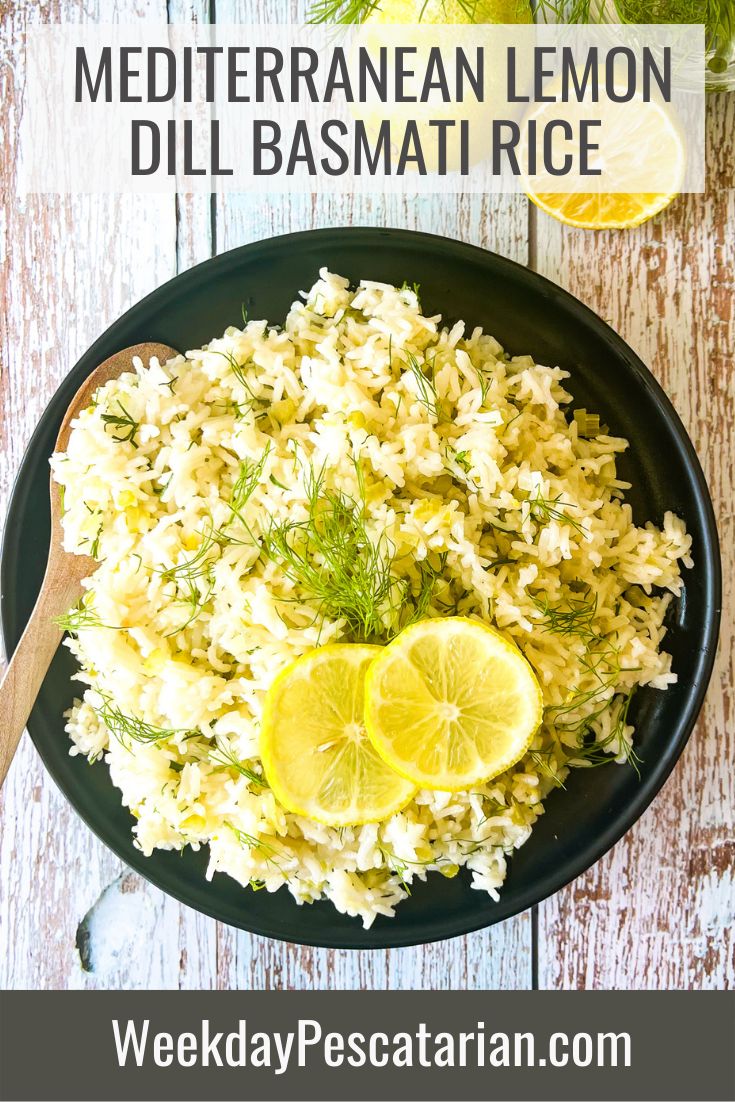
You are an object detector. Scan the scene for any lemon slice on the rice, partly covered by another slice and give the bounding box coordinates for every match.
[260,644,415,827]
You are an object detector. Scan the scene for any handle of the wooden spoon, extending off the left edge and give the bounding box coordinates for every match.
[0,555,82,788]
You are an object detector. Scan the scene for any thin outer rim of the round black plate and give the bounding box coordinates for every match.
[0,226,722,950]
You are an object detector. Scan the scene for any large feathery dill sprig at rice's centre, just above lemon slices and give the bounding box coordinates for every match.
[263,467,400,641]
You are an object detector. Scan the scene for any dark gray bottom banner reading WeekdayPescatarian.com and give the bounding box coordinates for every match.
[0,991,735,1102]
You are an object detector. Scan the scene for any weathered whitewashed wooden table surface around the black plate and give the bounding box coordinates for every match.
[0,0,735,988]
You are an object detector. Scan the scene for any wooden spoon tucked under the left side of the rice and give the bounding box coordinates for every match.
[0,342,179,786]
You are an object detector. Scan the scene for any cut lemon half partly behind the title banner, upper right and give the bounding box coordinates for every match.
[525,98,685,229]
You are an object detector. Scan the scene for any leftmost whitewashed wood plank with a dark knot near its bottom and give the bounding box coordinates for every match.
[0,0,216,988]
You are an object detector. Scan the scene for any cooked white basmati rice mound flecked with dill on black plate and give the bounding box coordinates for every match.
[52,270,691,927]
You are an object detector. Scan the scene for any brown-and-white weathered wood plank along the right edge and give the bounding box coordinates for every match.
[537,96,735,988]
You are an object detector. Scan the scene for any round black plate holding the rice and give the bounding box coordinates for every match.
[1,228,721,949]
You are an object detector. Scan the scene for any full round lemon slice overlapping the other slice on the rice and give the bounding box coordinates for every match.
[365,616,542,791]
